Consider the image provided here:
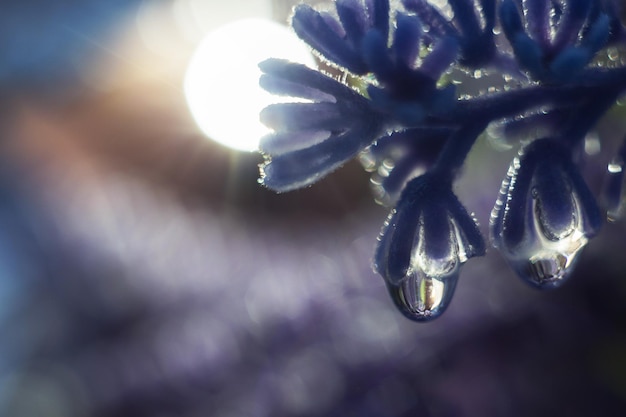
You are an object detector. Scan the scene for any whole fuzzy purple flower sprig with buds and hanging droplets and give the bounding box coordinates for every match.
[260,0,626,321]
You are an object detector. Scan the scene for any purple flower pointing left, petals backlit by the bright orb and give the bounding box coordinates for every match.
[260,59,385,191]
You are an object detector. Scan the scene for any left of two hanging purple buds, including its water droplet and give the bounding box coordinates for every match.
[374,175,485,321]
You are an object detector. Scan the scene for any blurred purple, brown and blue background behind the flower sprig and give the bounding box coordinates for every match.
[0,0,626,417]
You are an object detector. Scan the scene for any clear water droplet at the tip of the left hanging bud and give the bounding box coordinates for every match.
[387,268,459,321]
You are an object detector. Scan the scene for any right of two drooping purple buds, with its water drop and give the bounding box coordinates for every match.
[491,139,602,288]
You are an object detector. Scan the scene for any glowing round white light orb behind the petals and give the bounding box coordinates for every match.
[185,18,314,151]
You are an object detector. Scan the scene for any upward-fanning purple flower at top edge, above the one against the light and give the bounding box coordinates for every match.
[292,0,459,124]
